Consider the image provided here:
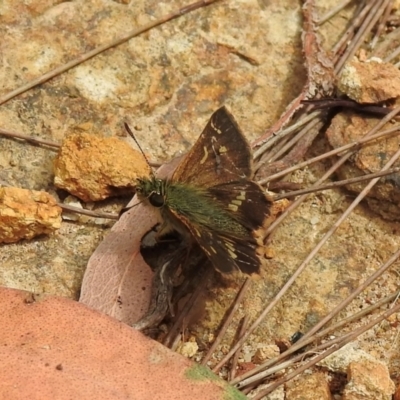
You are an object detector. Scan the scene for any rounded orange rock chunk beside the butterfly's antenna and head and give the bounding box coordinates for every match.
[54,133,150,201]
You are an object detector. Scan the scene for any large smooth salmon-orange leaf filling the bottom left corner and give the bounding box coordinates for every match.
[0,288,245,400]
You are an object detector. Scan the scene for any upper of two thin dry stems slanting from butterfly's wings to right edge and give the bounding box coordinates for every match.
[258,126,400,185]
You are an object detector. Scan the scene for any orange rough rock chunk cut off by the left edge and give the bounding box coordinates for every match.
[0,188,61,243]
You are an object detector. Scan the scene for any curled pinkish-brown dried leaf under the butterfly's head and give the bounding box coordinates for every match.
[79,159,179,325]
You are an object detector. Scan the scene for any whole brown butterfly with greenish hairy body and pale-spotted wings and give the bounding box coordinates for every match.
[137,107,271,274]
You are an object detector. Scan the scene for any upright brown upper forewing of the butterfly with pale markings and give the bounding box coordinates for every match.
[172,107,252,188]
